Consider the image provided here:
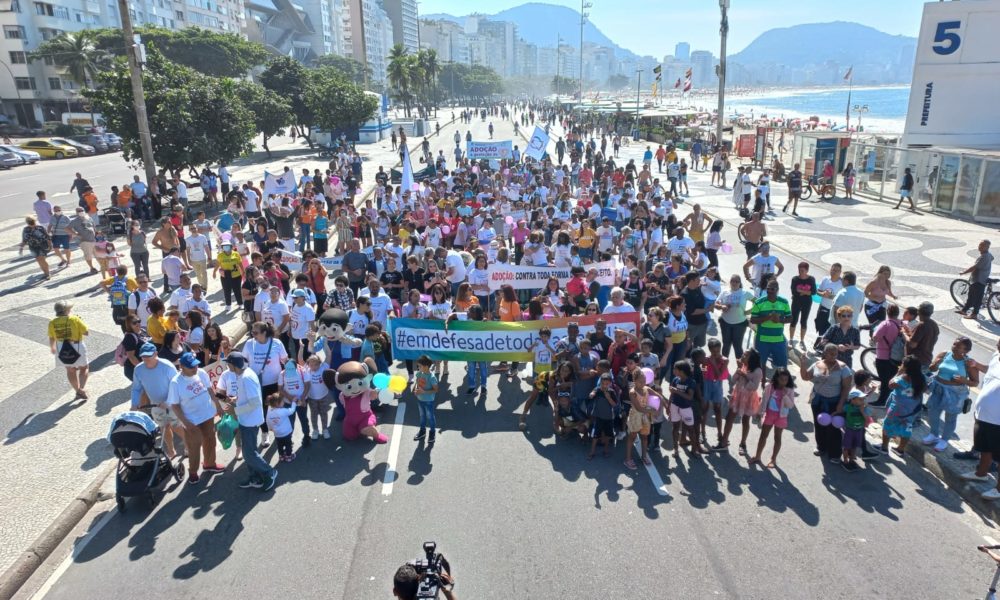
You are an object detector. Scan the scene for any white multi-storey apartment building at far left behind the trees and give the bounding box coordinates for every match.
[0,0,244,125]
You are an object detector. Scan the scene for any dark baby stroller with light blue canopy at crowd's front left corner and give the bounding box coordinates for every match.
[108,411,184,512]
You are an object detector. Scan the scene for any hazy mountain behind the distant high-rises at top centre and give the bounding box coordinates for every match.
[421,2,636,56]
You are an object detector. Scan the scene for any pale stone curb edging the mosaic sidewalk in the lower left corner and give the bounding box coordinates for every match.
[0,465,114,600]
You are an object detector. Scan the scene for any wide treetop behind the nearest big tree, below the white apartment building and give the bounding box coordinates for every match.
[91,27,271,77]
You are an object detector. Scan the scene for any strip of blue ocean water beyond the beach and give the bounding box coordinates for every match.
[726,86,910,132]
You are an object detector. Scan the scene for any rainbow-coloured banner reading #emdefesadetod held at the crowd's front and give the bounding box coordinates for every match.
[389,312,639,362]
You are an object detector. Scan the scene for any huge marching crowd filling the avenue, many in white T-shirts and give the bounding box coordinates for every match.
[33,104,1000,498]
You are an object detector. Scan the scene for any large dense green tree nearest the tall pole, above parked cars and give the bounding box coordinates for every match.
[84,48,256,171]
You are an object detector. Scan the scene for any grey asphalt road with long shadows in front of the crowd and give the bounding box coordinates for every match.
[23,113,992,600]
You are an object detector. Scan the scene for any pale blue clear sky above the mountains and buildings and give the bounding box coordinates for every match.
[419,0,923,58]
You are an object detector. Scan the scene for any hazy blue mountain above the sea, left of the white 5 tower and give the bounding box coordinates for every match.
[729,21,917,68]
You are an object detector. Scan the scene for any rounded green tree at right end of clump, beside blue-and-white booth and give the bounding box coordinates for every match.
[305,67,378,134]
